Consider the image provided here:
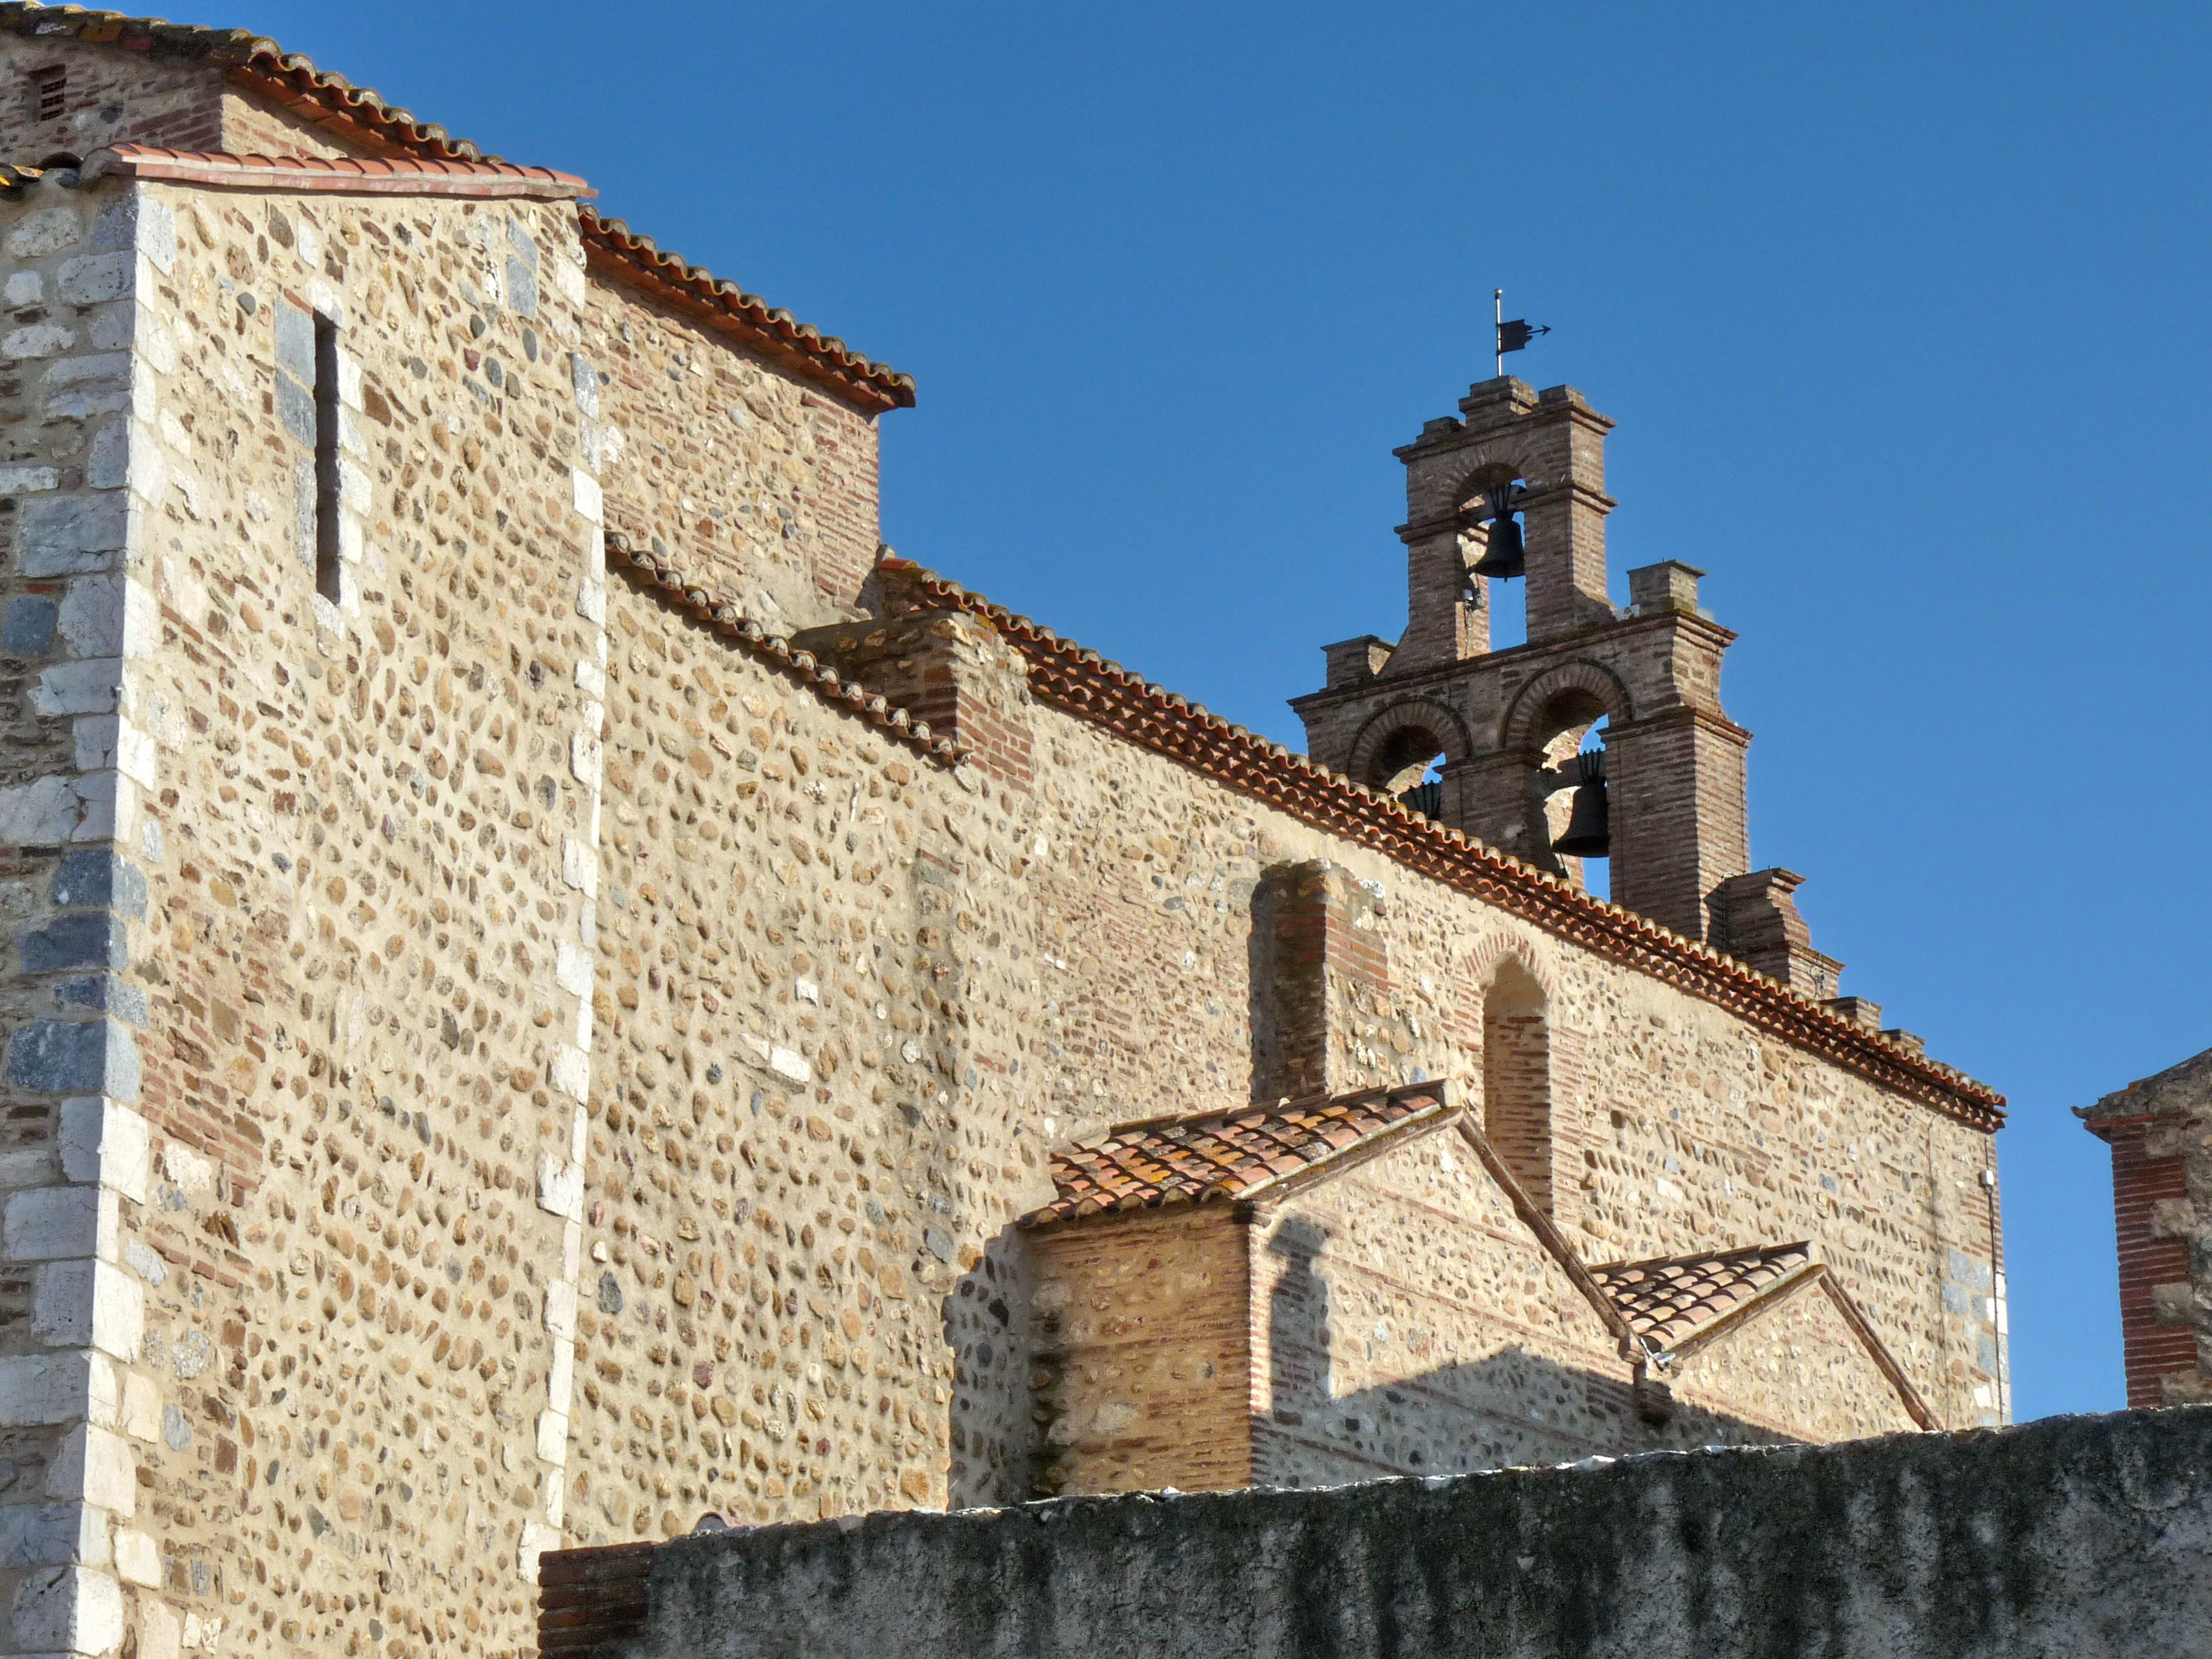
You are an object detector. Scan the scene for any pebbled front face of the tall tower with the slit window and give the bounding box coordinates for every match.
[109,190,597,1655]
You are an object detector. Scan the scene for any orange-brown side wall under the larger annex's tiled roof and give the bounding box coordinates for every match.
[1031,1205,1259,1493]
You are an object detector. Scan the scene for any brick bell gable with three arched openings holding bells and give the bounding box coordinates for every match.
[1292,376,1840,997]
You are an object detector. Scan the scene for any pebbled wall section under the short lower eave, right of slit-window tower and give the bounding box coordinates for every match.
[573,586,1051,1540]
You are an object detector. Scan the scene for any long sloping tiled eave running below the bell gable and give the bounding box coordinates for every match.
[878,557,2004,1130]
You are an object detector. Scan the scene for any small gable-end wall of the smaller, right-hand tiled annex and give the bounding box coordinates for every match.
[1670,1287,1918,1440]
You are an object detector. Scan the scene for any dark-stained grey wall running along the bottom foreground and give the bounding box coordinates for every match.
[542,1409,2212,1659]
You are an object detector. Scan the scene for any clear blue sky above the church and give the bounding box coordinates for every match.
[173,0,2212,1418]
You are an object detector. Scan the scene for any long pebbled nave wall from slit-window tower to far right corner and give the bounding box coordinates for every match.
[571,580,1997,1540]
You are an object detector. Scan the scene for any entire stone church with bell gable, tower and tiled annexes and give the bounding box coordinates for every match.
[0,13,2006,1659]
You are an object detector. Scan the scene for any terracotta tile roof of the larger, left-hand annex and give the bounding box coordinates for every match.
[1022,1084,1451,1225]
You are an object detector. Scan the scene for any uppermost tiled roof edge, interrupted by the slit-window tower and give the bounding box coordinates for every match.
[0,0,914,414]
